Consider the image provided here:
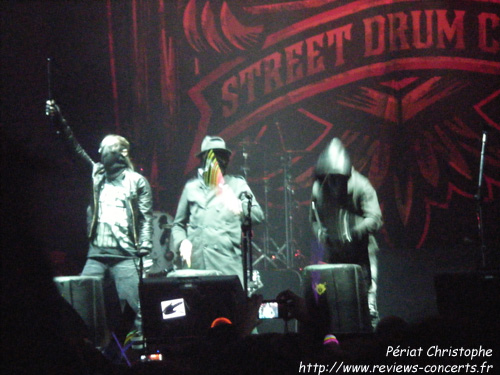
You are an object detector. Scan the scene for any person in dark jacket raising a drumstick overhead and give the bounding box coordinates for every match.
[46,100,153,336]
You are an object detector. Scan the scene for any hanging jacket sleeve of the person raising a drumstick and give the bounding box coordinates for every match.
[137,176,153,251]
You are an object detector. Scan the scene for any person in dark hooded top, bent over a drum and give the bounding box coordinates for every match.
[310,138,382,327]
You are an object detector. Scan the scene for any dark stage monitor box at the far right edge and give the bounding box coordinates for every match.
[434,270,500,327]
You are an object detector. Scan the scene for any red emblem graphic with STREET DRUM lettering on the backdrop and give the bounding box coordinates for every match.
[177,0,500,253]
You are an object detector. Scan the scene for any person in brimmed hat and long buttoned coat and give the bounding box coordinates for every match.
[170,136,264,285]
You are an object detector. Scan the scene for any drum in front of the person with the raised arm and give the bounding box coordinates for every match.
[54,276,109,347]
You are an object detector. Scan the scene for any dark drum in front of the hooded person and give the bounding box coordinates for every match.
[303,264,372,334]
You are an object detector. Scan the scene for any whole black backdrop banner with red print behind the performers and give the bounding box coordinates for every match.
[107,0,500,256]
